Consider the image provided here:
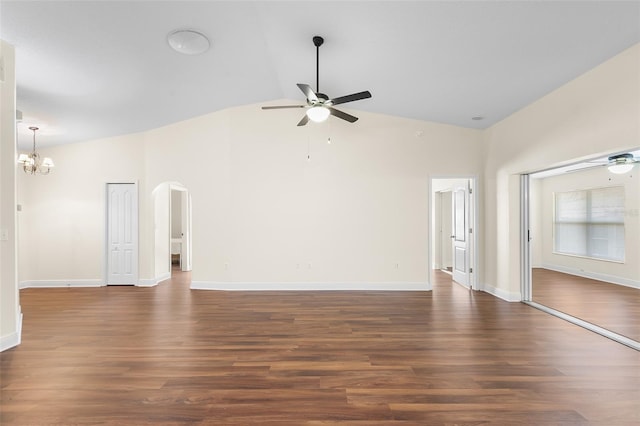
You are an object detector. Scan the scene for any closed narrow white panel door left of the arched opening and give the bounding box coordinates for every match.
[107,183,138,285]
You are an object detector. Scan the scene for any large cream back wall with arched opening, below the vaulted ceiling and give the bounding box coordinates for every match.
[20,105,482,289]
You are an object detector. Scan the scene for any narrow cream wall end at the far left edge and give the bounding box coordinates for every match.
[0,40,22,351]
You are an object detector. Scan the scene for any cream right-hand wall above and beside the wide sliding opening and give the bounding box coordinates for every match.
[484,45,640,300]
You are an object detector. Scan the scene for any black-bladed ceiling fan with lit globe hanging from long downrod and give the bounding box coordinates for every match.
[262,36,371,126]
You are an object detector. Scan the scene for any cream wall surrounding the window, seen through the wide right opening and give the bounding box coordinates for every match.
[531,167,640,288]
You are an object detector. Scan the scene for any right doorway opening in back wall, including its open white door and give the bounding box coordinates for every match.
[429,177,477,289]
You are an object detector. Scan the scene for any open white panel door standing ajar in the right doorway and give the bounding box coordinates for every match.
[452,185,470,286]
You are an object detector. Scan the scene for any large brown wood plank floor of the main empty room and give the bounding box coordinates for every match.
[0,272,640,426]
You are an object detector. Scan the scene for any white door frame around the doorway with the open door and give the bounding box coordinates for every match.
[428,175,482,290]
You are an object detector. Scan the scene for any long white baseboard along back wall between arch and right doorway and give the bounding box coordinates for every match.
[190,281,432,291]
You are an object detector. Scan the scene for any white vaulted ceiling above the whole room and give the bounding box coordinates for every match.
[0,0,640,150]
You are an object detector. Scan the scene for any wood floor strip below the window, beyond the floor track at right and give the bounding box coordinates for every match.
[532,268,640,342]
